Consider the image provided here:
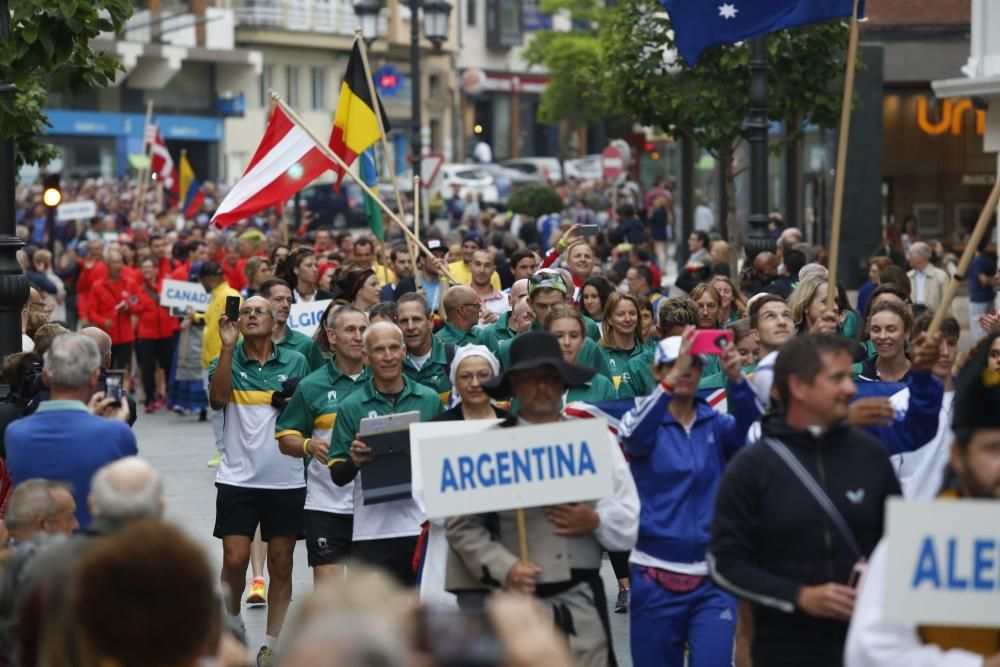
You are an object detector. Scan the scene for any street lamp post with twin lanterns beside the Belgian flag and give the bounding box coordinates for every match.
[350,0,451,184]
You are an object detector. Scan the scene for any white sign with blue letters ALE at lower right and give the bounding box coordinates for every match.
[885,498,1000,628]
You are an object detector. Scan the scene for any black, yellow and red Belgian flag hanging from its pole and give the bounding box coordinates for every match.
[330,41,391,190]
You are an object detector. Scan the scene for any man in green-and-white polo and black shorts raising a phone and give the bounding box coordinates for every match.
[208,296,310,665]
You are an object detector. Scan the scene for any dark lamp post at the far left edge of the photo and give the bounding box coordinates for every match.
[0,0,28,356]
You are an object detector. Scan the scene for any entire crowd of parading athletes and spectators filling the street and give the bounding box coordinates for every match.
[0,172,1000,667]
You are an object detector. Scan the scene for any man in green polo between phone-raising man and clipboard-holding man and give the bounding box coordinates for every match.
[274,306,371,583]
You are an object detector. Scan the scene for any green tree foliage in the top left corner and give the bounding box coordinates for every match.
[0,0,132,166]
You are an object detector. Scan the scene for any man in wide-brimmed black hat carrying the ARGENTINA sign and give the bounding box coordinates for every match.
[445,331,639,667]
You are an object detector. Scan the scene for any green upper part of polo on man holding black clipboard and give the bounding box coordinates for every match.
[329,375,443,464]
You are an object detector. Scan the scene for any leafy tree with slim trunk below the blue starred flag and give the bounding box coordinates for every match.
[594,0,849,268]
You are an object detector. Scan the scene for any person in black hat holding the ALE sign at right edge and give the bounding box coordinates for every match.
[845,334,1000,667]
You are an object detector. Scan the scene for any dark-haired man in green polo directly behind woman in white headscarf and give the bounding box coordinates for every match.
[396,292,455,406]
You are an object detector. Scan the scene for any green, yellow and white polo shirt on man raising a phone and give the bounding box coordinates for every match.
[208,340,312,489]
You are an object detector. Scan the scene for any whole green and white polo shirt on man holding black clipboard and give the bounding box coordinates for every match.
[329,375,443,542]
